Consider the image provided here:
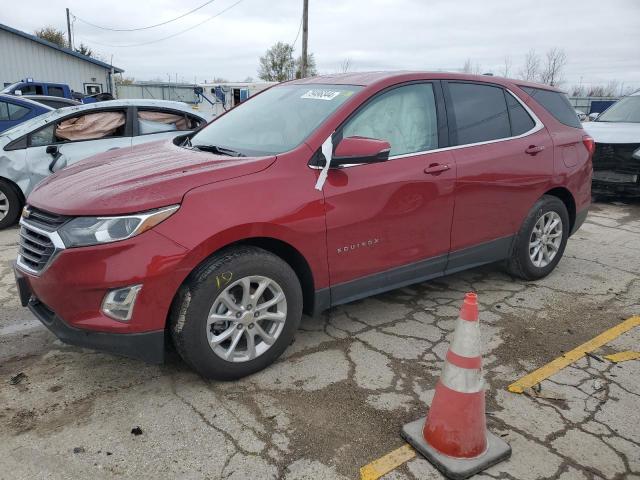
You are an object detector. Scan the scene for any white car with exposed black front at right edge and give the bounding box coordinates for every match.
[582,91,640,196]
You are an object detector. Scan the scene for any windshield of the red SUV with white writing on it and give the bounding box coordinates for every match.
[191,85,362,155]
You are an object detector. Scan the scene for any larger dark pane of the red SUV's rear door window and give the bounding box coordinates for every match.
[448,82,511,145]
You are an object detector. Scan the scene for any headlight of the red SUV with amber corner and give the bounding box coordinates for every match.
[58,205,180,247]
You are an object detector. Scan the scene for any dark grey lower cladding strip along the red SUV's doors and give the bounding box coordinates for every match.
[313,236,515,314]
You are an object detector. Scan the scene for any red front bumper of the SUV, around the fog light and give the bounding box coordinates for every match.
[14,230,191,363]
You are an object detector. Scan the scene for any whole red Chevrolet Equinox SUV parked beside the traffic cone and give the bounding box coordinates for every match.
[16,72,593,379]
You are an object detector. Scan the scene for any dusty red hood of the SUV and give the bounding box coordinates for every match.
[27,140,276,215]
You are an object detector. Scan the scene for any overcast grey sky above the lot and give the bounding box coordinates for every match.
[0,0,640,88]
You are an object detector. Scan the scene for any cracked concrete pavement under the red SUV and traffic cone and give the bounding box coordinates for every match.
[0,203,640,480]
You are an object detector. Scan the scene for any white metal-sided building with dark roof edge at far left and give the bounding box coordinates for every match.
[0,23,124,94]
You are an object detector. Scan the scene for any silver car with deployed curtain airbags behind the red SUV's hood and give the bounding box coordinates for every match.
[0,99,207,229]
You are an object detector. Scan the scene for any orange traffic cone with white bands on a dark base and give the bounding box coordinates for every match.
[402,293,511,479]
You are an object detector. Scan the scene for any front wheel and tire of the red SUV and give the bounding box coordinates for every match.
[169,247,302,380]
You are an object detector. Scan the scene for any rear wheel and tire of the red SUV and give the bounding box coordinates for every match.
[508,195,571,280]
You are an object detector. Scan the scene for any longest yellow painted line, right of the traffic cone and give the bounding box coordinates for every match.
[507,316,640,393]
